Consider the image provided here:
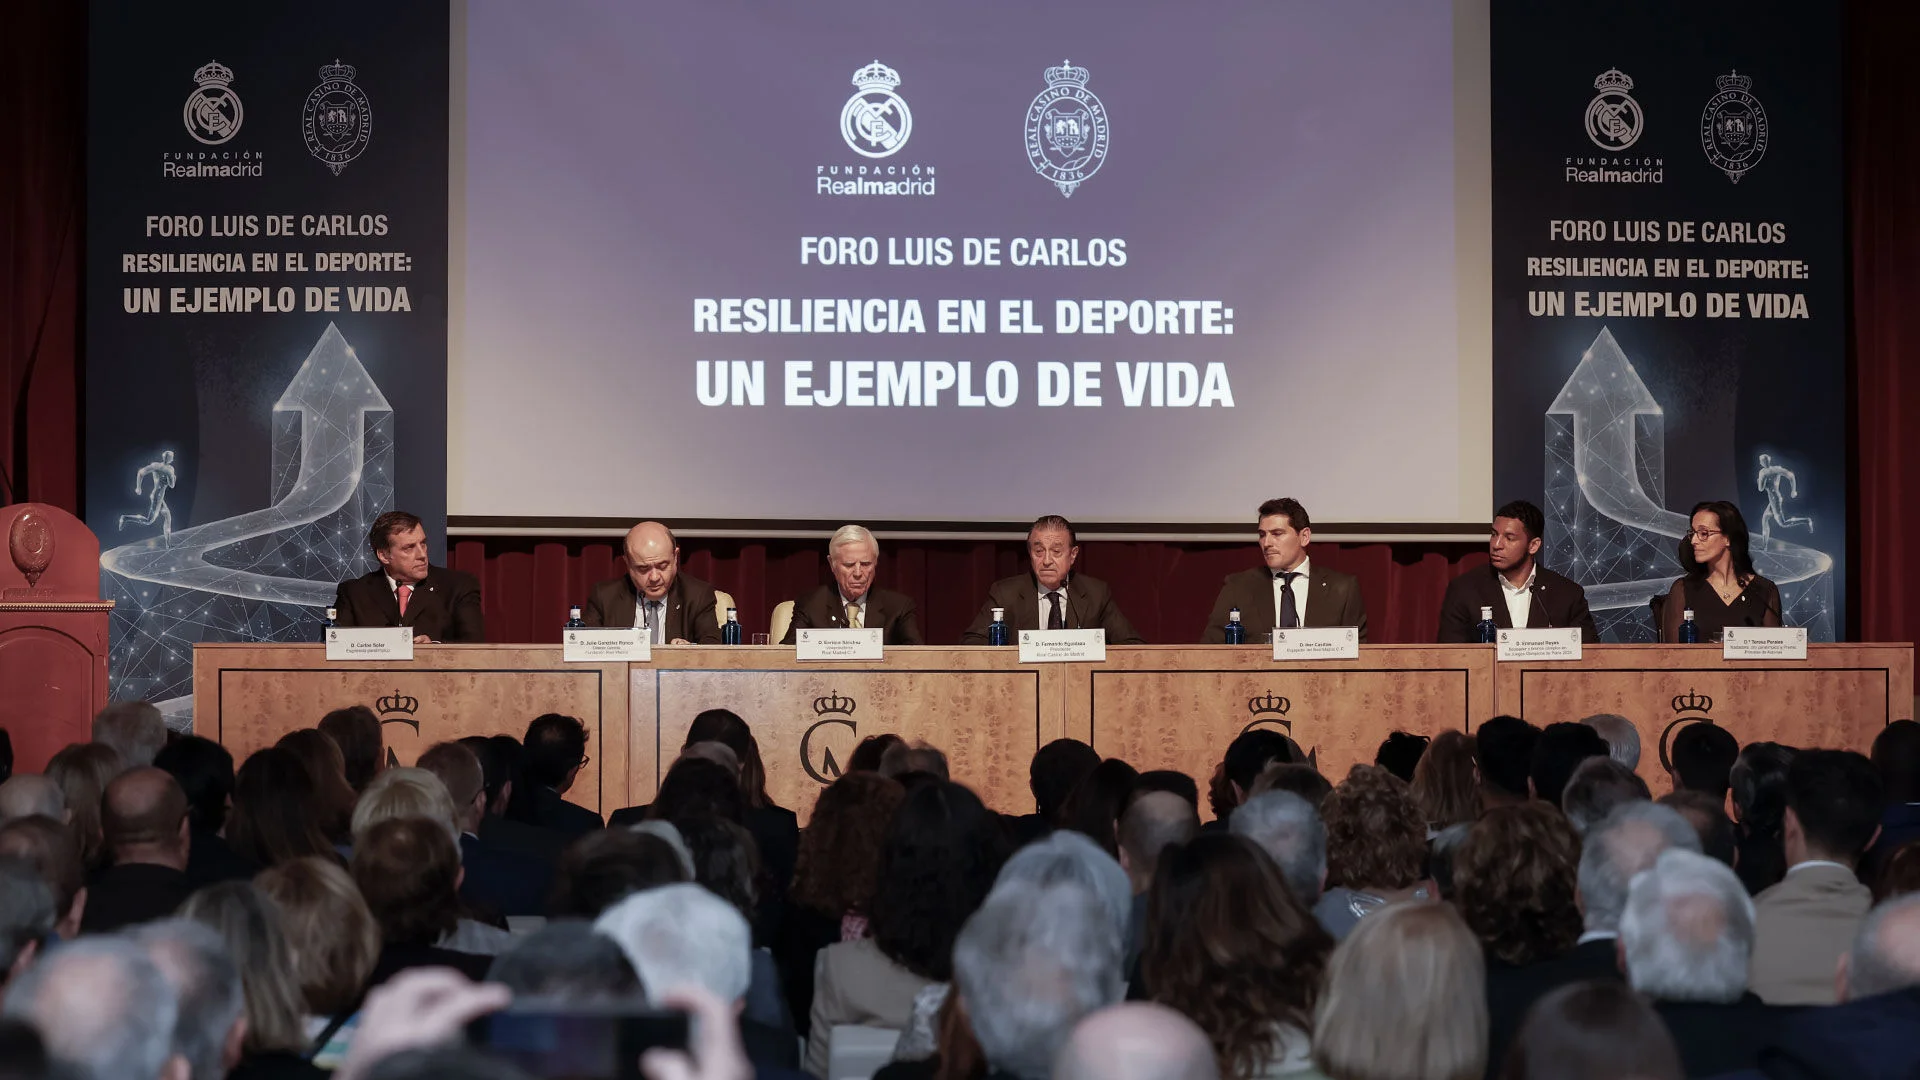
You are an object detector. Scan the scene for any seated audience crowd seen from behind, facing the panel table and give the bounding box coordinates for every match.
[0,703,1920,1080]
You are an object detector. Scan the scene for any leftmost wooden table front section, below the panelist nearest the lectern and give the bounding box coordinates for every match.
[194,644,628,813]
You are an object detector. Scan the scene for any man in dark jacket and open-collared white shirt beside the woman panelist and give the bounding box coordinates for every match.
[1436,500,1599,646]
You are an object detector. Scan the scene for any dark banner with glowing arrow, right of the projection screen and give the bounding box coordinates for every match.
[1492,0,1847,642]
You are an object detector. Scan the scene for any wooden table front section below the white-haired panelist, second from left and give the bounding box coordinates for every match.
[630,646,1062,822]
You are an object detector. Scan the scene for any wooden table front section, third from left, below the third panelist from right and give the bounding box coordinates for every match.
[1068,646,1494,810]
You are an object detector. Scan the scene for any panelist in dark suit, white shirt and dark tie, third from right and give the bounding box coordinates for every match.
[1200,500,1367,646]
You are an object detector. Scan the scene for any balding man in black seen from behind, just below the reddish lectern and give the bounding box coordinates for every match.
[81,767,194,934]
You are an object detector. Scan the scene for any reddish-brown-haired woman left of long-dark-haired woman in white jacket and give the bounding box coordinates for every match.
[774,773,906,1036]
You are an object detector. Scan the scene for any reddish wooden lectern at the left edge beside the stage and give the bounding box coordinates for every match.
[0,502,113,773]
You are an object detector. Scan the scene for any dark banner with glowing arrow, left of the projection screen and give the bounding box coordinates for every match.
[86,0,447,717]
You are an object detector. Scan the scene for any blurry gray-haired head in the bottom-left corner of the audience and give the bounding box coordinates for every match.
[4,938,188,1080]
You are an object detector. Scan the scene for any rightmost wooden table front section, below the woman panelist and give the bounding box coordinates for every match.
[1498,644,1914,794]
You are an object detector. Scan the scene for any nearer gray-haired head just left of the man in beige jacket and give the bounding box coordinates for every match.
[1620,849,1753,1005]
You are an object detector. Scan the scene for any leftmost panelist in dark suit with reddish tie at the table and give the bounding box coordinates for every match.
[334,509,486,644]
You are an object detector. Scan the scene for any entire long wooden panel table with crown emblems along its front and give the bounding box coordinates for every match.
[194,644,1912,817]
